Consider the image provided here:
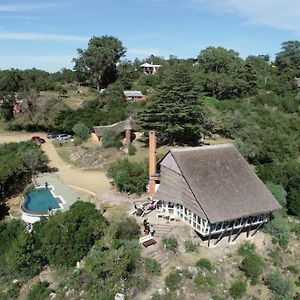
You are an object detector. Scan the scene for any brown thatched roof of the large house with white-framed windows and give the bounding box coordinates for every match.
[154,144,280,223]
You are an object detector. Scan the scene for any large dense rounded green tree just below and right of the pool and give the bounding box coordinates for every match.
[34,201,107,268]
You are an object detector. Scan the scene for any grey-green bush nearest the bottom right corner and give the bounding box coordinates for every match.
[265,272,293,296]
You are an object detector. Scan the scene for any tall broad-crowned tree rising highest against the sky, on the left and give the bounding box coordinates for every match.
[73,35,125,91]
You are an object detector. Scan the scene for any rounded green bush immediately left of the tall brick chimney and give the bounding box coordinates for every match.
[107,158,148,195]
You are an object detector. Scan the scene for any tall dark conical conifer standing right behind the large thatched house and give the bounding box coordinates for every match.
[140,66,203,144]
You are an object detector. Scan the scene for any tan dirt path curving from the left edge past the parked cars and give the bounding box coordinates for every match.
[0,132,111,194]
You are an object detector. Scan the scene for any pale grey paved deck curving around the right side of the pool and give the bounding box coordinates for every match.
[34,174,82,211]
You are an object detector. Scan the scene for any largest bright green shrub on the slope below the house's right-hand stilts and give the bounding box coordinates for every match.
[240,253,264,285]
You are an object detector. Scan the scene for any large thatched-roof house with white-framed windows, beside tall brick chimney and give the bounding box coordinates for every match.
[153,144,280,246]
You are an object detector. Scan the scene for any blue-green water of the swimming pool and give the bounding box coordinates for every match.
[24,188,60,211]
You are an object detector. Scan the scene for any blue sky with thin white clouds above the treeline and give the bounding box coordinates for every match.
[0,0,300,72]
